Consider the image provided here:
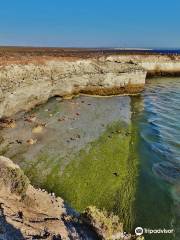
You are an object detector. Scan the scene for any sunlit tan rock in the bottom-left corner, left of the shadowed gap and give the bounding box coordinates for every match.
[0,156,69,240]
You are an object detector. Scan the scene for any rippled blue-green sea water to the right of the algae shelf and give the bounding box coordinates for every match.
[133,78,180,240]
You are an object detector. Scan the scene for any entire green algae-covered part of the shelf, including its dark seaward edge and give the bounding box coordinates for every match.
[21,122,137,230]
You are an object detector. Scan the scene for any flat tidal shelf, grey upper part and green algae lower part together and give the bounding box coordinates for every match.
[0,97,138,231]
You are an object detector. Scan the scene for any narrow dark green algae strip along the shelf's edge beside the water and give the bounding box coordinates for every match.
[112,117,139,231]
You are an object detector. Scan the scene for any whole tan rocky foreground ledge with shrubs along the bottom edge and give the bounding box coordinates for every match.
[0,156,143,240]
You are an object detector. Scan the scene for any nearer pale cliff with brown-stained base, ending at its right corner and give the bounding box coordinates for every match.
[0,59,146,118]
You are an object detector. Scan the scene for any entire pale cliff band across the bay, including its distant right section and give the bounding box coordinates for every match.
[0,55,180,118]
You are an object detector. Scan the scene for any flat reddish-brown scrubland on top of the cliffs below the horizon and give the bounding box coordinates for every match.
[0,47,180,65]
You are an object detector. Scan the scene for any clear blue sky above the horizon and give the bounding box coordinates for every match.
[0,0,180,48]
